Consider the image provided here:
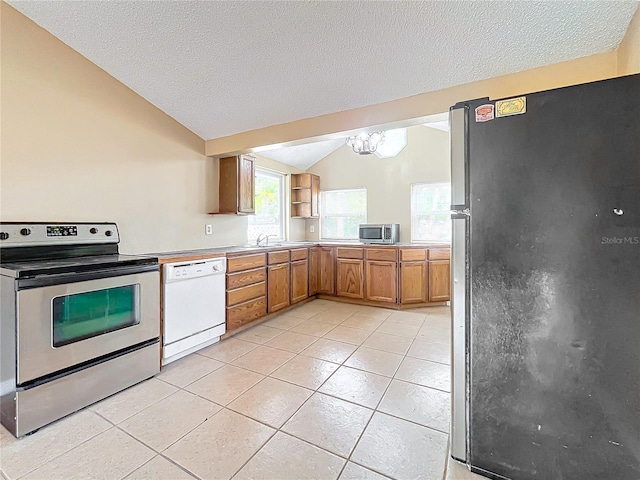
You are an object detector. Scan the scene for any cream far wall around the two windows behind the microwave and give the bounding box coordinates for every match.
[307,126,450,242]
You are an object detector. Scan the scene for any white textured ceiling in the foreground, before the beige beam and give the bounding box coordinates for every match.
[9,0,638,139]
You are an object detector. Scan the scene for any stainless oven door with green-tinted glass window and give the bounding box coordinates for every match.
[17,265,160,385]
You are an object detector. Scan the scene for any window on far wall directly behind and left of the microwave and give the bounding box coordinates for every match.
[320,188,367,240]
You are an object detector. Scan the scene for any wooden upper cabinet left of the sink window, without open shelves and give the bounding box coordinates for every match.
[215,155,256,215]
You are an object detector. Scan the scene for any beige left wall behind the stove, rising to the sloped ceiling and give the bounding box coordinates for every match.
[0,2,304,253]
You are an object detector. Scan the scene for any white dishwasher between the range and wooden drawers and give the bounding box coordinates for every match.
[162,258,227,365]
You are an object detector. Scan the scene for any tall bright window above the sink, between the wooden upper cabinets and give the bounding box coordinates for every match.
[248,168,284,242]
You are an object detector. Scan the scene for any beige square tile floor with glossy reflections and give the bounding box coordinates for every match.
[0,300,481,480]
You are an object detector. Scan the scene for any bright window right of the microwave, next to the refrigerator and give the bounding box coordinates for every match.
[411,182,451,242]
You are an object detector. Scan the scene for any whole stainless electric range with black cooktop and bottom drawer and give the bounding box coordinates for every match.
[0,223,160,437]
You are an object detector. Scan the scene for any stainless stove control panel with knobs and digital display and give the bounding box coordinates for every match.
[0,222,120,247]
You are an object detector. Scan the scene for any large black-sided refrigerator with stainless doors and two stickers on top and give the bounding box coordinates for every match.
[450,74,640,480]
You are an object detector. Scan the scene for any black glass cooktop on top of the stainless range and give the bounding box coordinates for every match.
[1,254,158,278]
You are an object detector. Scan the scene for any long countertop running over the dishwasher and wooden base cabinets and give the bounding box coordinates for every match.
[147,242,450,263]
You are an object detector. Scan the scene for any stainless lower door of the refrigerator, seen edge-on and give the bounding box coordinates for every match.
[451,215,469,462]
